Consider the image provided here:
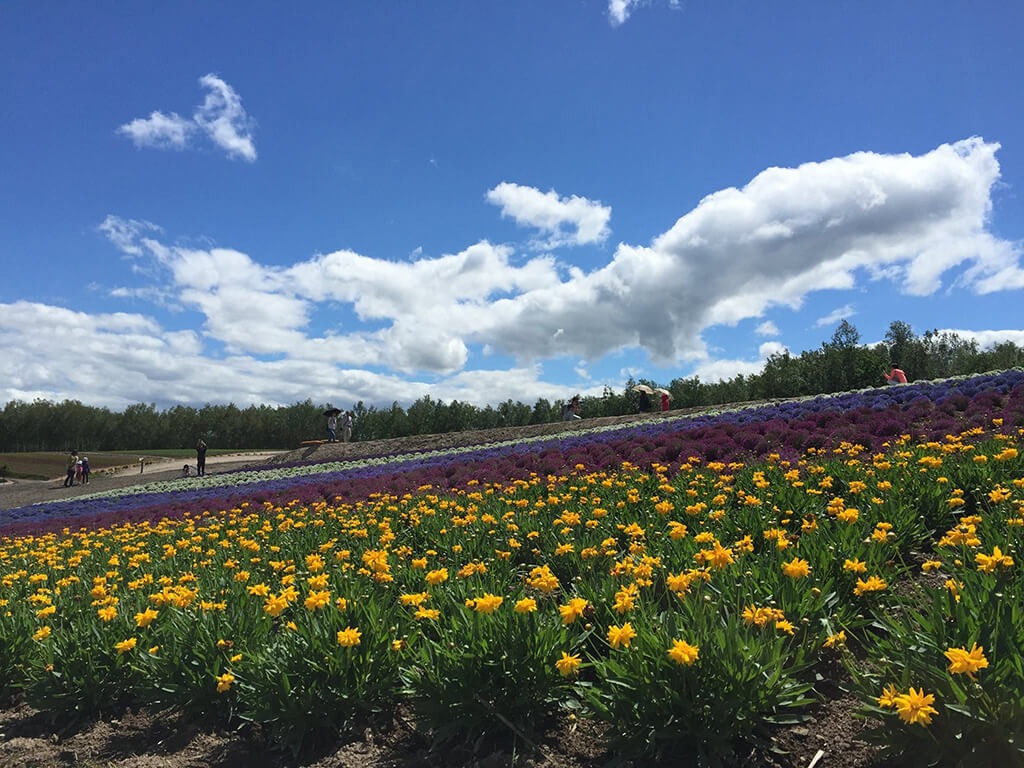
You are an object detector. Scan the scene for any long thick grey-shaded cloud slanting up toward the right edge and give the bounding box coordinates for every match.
[477,138,1021,370]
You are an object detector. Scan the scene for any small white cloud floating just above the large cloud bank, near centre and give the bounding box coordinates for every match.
[486,181,611,248]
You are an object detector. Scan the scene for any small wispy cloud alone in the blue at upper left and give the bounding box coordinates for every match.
[118,75,256,163]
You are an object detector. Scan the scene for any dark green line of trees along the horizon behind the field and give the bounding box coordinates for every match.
[0,321,1024,452]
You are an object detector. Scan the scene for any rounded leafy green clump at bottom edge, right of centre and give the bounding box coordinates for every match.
[586,601,812,767]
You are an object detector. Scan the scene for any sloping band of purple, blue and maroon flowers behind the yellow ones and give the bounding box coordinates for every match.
[0,369,1024,536]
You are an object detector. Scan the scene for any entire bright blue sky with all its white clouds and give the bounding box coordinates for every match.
[0,0,1024,410]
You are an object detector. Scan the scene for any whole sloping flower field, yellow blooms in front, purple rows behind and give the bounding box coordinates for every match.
[0,370,1024,766]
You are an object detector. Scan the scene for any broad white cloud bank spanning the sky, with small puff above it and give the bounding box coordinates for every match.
[6,139,1024,404]
